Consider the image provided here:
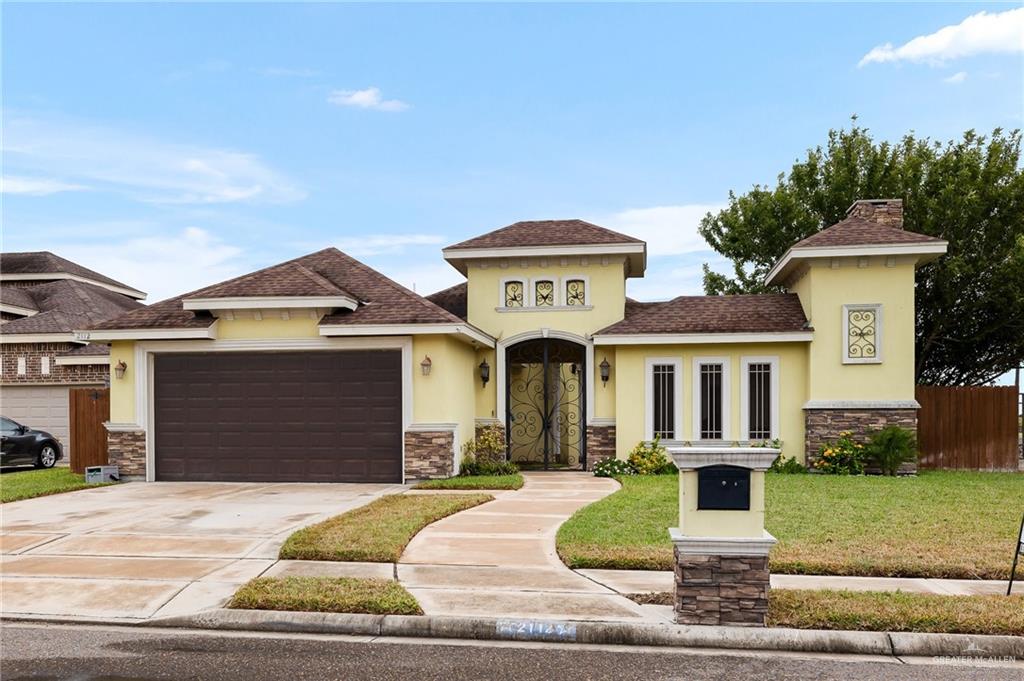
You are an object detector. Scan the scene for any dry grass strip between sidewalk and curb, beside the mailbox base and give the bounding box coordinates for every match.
[629,589,1024,636]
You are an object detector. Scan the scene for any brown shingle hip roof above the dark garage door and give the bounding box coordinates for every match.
[93,248,463,330]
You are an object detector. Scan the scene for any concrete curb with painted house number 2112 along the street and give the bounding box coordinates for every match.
[140,609,1024,659]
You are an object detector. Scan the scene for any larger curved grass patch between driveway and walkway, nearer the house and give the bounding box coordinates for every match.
[281,495,494,562]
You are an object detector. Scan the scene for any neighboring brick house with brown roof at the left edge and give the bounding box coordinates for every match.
[0,251,145,463]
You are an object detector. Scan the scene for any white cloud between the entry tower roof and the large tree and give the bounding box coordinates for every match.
[595,204,725,255]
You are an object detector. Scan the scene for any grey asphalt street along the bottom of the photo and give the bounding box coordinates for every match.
[0,623,1024,681]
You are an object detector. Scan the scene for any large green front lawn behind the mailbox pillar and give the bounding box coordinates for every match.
[558,471,1024,580]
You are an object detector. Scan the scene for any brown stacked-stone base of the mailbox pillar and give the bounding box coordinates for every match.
[676,548,769,627]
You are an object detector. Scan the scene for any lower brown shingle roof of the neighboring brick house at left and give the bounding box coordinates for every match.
[0,280,144,335]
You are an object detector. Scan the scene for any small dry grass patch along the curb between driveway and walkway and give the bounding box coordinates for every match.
[227,577,423,614]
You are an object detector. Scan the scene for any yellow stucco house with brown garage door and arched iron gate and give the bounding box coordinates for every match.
[89,201,946,481]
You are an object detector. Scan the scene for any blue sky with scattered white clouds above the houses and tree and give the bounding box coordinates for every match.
[2,3,1024,300]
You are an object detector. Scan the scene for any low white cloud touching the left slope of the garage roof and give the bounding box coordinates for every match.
[58,226,247,303]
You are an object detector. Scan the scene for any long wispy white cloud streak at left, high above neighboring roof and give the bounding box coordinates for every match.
[3,116,305,204]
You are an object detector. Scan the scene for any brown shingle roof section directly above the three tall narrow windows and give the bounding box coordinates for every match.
[595,293,807,336]
